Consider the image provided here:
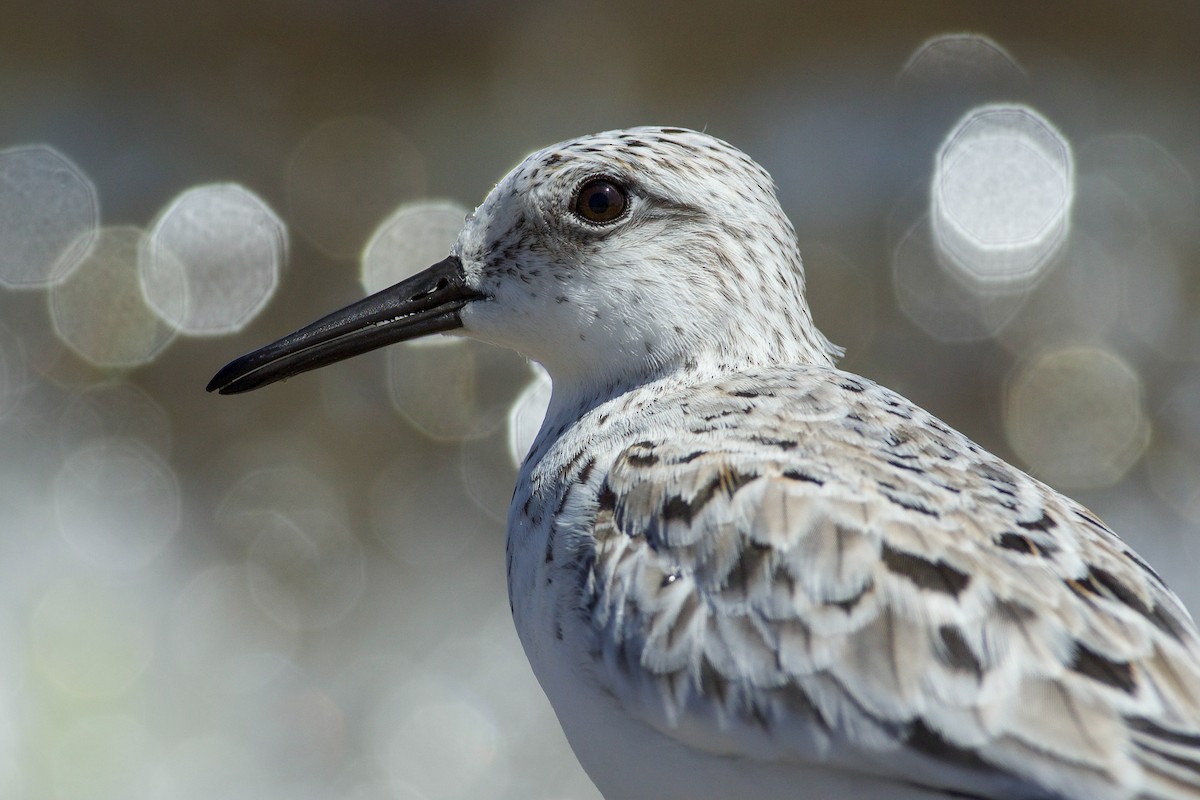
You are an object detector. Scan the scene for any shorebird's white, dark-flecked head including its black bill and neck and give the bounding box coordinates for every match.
[209,127,834,393]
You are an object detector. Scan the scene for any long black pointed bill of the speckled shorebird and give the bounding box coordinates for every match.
[208,255,481,395]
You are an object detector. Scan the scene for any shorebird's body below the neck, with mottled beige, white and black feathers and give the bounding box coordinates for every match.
[509,366,1200,799]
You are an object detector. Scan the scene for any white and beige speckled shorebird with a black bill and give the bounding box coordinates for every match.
[208,127,1200,800]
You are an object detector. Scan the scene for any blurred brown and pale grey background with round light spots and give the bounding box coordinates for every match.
[0,0,1200,800]
